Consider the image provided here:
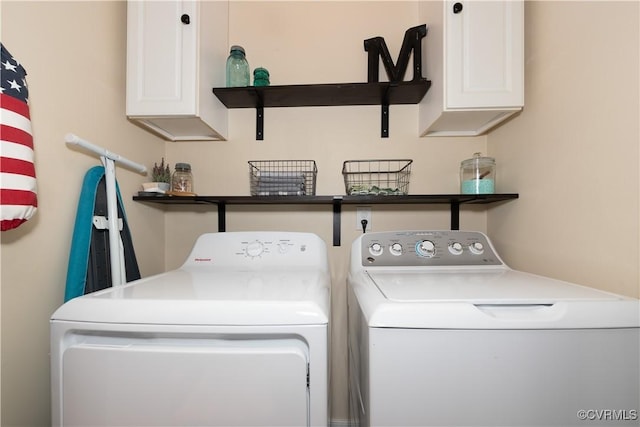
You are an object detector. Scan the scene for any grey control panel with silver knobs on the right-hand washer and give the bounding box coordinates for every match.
[360,230,503,266]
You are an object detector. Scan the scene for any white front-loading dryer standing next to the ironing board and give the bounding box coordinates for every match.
[51,232,330,427]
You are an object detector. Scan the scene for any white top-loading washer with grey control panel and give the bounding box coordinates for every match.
[348,231,640,427]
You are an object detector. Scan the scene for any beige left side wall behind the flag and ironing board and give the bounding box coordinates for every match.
[0,1,165,426]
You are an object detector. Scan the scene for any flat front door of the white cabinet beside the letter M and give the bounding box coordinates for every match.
[444,0,524,108]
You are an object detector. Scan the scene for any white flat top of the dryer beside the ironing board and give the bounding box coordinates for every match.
[52,268,330,325]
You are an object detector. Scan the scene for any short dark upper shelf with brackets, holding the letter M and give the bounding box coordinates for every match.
[213,79,431,140]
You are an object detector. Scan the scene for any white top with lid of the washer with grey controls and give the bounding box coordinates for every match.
[356,269,640,329]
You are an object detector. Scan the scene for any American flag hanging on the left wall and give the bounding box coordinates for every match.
[0,43,38,231]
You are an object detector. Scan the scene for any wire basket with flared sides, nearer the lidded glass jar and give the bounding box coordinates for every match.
[342,159,413,196]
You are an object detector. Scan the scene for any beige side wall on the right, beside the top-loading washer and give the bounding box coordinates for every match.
[488,1,640,296]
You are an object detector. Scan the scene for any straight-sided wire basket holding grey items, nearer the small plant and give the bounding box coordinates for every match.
[249,160,318,196]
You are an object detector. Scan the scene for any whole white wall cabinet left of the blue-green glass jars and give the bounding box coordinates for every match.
[126,0,229,141]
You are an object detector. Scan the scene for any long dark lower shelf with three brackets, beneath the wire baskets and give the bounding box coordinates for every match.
[133,193,519,246]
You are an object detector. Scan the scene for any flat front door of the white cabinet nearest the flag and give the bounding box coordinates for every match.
[127,1,199,116]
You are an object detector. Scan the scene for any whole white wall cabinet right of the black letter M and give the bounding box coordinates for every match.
[419,0,524,136]
